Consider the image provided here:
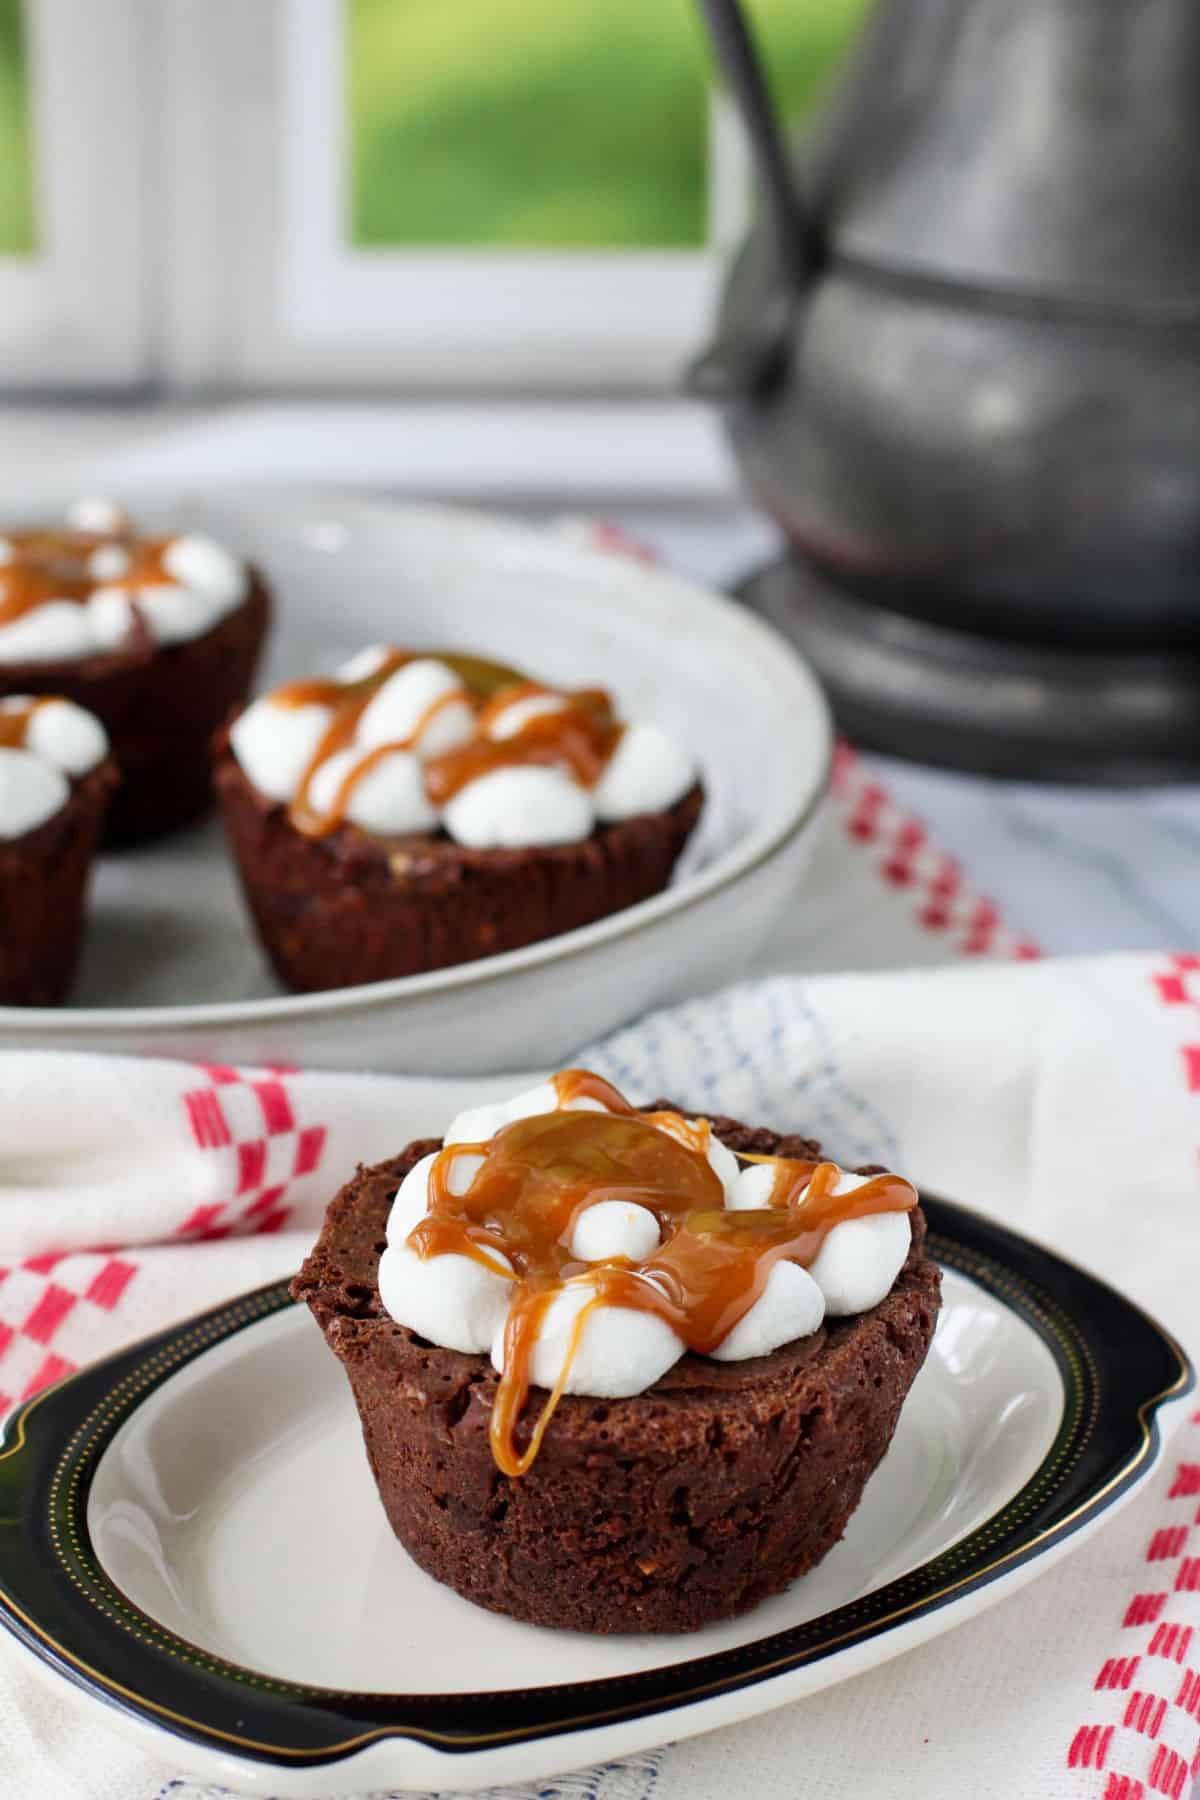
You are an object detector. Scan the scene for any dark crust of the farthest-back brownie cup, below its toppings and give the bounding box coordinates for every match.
[0,571,270,844]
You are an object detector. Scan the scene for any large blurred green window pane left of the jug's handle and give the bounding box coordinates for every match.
[347,0,707,248]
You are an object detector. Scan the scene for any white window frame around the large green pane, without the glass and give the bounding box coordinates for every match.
[162,0,747,394]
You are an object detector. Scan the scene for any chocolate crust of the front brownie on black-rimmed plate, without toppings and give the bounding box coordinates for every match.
[291,1102,939,1633]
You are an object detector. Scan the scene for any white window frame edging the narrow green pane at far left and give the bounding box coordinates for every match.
[0,0,148,389]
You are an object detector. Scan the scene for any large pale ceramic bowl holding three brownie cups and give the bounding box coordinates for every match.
[0,491,831,1075]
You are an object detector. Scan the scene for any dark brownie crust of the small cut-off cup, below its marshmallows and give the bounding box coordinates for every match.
[0,758,117,1006]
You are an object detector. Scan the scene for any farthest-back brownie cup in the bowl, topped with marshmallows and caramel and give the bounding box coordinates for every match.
[0,500,270,844]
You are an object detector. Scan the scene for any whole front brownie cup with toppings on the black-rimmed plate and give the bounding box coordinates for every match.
[291,1073,939,1633]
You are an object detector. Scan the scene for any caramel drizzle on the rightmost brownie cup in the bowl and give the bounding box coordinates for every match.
[272,650,622,837]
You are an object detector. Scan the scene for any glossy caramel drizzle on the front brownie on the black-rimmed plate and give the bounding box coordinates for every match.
[408,1069,918,1476]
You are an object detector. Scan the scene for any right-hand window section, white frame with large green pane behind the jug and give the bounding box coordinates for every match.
[167,0,865,392]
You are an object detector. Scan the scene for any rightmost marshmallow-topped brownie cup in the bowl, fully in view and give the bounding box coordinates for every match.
[216,648,703,992]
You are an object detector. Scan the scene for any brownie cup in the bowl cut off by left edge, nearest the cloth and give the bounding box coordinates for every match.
[0,697,117,1006]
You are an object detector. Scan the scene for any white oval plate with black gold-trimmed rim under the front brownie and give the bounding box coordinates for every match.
[0,1201,1193,1796]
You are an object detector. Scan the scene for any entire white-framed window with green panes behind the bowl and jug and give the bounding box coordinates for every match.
[0,0,867,394]
